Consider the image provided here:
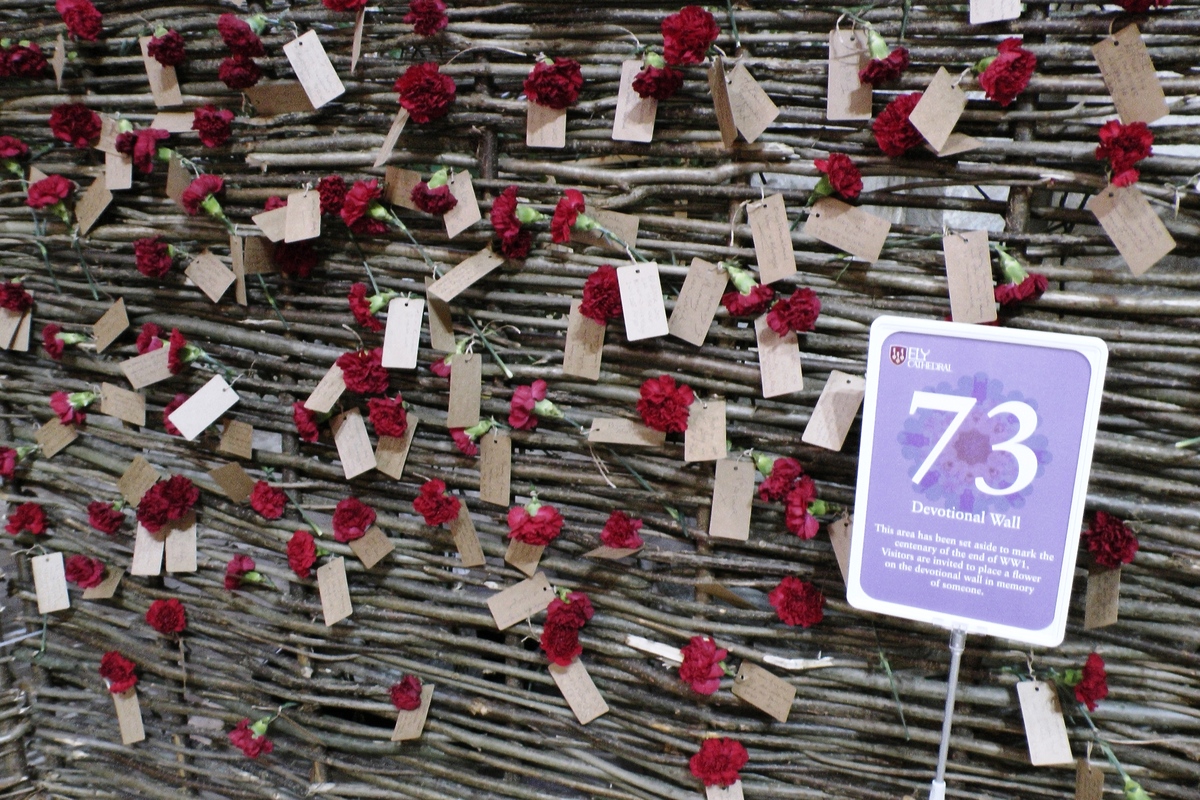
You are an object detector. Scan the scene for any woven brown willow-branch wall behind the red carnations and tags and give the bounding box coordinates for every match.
[0,0,1200,800]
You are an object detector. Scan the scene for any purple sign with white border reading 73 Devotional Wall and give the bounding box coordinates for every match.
[847,318,1106,644]
